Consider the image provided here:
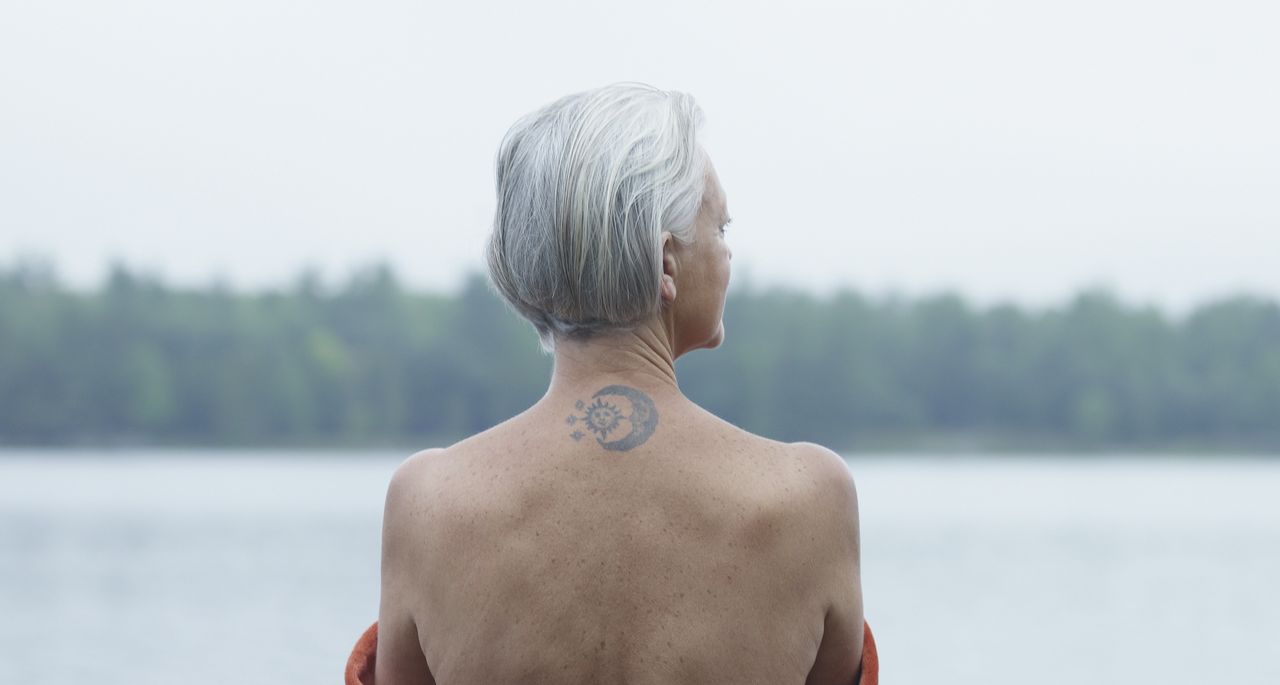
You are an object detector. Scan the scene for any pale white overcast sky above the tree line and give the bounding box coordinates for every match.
[0,0,1280,311]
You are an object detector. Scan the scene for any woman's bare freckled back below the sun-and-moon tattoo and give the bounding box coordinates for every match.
[373,393,861,684]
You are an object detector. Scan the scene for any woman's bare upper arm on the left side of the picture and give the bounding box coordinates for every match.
[374,451,435,685]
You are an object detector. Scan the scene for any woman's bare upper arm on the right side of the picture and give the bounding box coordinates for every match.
[800,443,863,685]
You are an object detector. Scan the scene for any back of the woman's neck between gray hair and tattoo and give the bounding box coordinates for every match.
[547,319,680,398]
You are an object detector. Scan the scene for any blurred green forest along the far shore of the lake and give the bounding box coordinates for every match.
[0,254,1280,453]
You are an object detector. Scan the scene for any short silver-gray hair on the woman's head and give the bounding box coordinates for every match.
[485,83,707,352]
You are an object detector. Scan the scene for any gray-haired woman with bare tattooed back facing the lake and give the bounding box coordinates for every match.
[348,83,876,685]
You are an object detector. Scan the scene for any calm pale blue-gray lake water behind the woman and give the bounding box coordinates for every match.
[0,449,1280,685]
